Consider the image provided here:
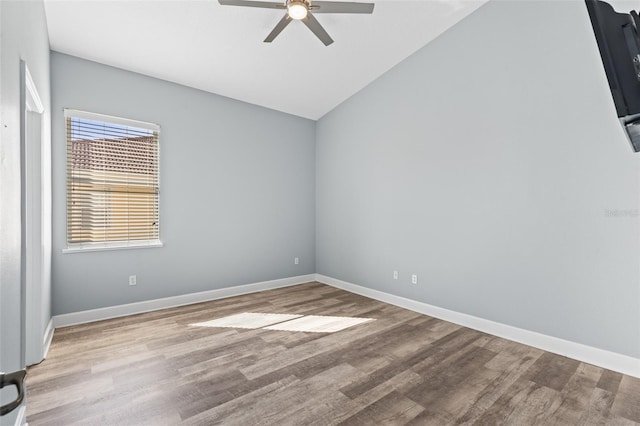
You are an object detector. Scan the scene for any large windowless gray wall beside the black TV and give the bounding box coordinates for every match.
[316,1,640,357]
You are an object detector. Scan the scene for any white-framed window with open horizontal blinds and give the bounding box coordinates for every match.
[64,109,162,251]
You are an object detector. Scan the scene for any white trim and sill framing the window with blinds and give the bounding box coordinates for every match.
[63,108,164,254]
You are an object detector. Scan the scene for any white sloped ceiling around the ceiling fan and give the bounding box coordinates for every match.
[45,0,486,120]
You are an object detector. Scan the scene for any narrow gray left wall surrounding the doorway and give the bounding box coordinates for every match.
[0,1,51,424]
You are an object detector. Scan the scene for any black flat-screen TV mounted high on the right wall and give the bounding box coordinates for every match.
[586,0,640,152]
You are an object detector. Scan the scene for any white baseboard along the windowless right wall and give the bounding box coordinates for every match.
[315,274,640,378]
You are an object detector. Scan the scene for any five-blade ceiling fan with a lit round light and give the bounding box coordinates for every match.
[218,0,374,46]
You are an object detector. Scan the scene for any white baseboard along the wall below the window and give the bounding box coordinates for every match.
[53,274,315,328]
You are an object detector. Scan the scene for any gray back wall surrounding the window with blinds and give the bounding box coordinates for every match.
[51,52,315,314]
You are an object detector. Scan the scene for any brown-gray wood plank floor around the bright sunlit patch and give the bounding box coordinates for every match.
[27,283,640,426]
